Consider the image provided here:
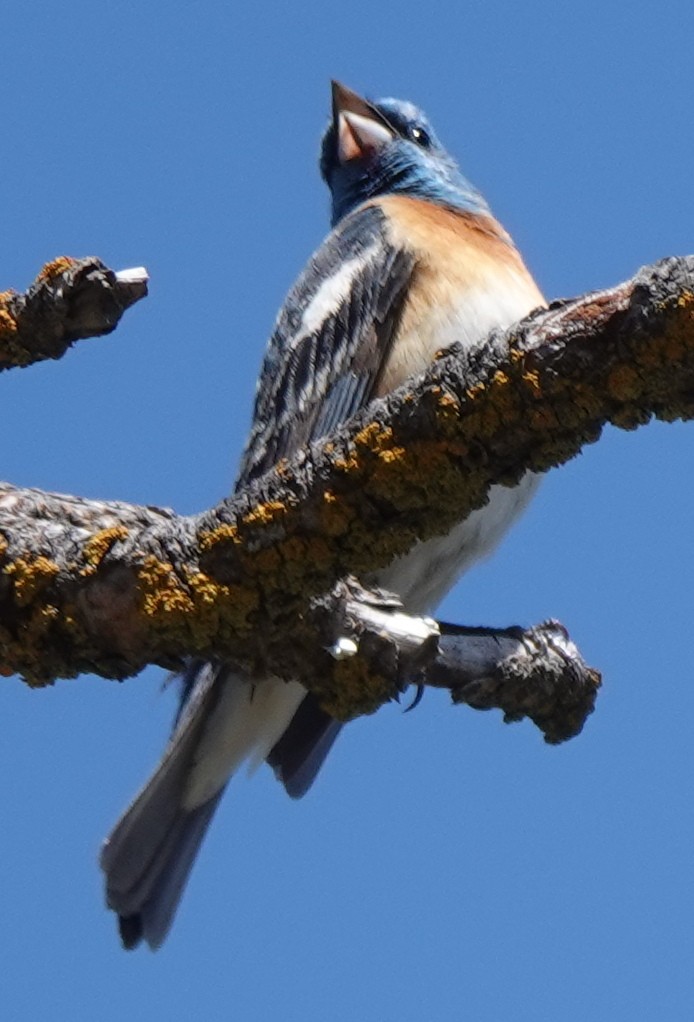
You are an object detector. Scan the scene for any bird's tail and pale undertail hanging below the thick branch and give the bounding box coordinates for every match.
[101,662,340,948]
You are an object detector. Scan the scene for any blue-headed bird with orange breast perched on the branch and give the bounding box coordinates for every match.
[100,82,545,949]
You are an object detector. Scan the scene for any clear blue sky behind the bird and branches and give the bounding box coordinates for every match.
[0,0,694,1022]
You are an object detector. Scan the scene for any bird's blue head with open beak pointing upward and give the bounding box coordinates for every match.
[320,82,490,225]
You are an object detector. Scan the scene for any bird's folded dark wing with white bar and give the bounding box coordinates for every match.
[236,205,415,487]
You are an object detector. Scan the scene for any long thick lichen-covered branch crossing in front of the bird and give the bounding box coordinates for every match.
[0,258,694,716]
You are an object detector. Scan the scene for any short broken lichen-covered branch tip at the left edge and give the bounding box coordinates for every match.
[0,257,147,370]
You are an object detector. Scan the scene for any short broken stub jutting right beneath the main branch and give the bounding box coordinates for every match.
[310,578,600,743]
